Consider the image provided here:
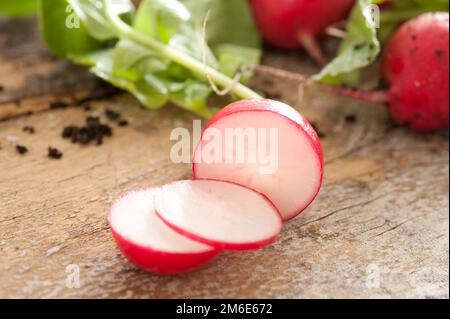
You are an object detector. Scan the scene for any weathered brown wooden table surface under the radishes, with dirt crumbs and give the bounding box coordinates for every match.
[0,15,449,298]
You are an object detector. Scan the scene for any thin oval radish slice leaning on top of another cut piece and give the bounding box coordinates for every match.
[155,180,282,250]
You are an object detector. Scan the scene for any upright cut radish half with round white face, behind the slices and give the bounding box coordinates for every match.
[193,99,323,220]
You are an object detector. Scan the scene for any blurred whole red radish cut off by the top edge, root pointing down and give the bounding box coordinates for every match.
[250,0,355,65]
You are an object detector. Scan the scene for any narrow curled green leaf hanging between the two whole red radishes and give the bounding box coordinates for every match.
[314,0,380,85]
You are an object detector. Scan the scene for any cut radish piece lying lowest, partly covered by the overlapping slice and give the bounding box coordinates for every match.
[108,189,218,275]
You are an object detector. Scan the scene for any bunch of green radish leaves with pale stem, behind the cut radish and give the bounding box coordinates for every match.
[39,0,261,117]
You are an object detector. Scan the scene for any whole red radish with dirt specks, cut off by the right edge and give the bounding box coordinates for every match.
[382,12,449,132]
